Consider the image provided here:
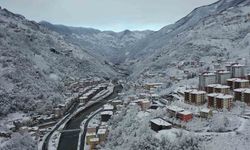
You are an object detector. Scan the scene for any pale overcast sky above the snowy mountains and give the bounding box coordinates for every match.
[0,0,217,31]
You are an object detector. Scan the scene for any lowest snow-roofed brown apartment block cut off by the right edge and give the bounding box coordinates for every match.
[234,88,250,105]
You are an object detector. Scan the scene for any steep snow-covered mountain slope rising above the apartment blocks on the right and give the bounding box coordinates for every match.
[128,0,250,75]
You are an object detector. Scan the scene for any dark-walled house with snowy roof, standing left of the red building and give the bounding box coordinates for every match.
[150,118,172,132]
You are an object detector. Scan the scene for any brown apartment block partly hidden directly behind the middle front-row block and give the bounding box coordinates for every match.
[205,84,230,94]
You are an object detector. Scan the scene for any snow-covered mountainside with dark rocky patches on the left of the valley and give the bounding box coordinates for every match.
[0,6,117,115]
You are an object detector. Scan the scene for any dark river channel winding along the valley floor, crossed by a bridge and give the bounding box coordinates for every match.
[58,85,122,150]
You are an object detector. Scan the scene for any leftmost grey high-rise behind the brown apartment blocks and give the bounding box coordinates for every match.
[199,72,216,90]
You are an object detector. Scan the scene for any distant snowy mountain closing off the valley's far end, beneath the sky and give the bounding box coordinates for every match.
[40,21,153,63]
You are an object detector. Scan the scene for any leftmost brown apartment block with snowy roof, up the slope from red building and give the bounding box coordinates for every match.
[184,89,206,105]
